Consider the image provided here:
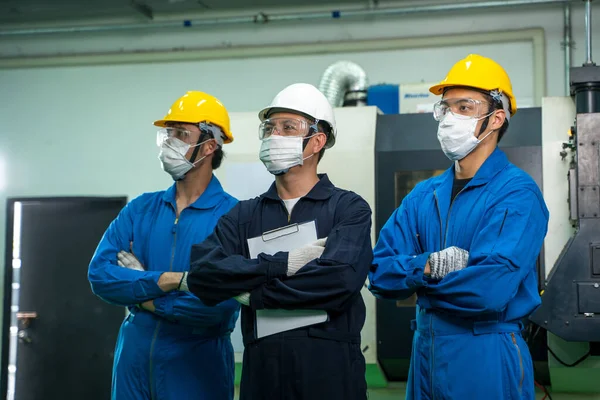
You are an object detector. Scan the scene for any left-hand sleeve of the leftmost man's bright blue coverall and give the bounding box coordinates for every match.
[88,203,164,306]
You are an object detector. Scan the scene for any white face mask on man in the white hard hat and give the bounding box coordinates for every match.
[259,135,314,175]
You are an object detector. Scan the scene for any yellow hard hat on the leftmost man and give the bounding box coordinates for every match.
[154,91,233,143]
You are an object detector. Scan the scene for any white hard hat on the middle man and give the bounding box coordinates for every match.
[258,83,337,149]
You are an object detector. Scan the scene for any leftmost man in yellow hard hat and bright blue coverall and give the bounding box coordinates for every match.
[88,92,239,400]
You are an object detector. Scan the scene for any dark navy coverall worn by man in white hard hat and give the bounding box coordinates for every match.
[187,175,373,400]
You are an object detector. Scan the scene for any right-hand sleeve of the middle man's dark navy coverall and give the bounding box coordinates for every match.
[250,196,373,312]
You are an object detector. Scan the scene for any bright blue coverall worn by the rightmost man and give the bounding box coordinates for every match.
[369,149,548,400]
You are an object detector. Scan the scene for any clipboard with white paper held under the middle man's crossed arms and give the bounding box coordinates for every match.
[248,221,329,338]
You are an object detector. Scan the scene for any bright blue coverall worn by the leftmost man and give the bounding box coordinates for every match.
[88,176,239,400]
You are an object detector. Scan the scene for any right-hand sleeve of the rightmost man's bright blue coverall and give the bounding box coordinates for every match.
[421,189,548,316]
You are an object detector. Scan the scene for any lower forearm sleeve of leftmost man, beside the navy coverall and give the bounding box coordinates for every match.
[154,292,240,328]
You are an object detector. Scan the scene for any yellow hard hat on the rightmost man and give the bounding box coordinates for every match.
[429,54,517,116]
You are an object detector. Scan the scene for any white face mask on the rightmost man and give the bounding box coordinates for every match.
[438,113,494,161]
